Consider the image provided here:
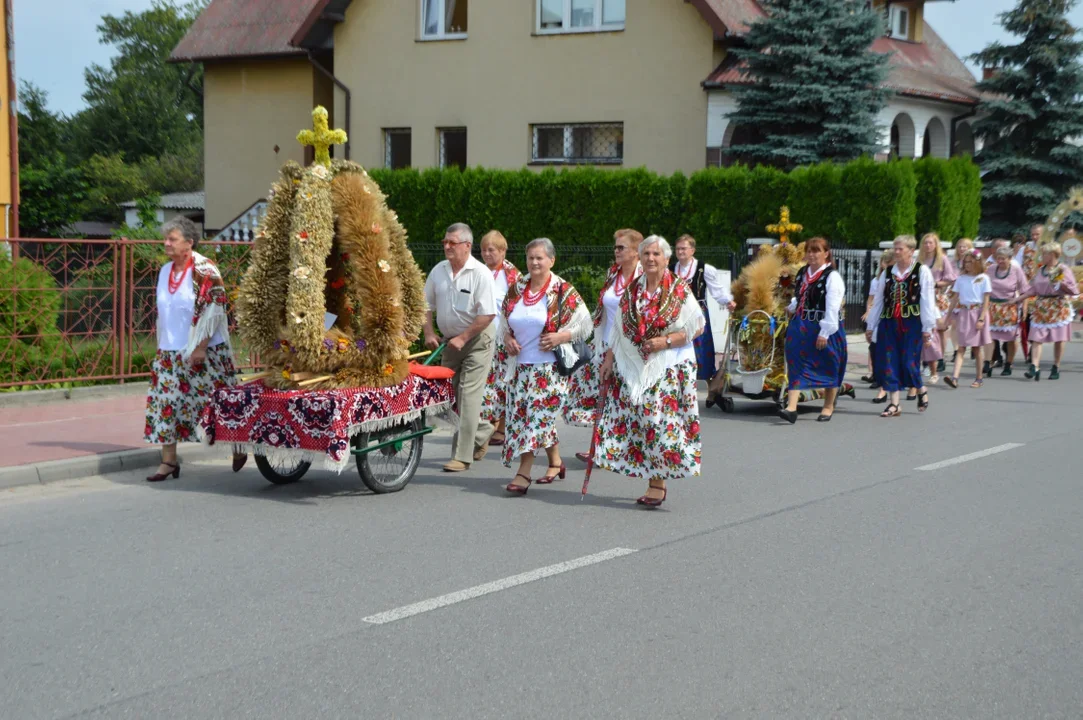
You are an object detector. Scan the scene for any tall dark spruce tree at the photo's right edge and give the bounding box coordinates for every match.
[973,0,1083,237]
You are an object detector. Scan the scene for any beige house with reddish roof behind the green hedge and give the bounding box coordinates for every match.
[172,0,976,237]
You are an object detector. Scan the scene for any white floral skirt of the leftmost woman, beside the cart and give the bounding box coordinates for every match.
[143,343,237,445]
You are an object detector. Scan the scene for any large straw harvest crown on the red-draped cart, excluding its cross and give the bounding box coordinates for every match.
[237,111,425,390]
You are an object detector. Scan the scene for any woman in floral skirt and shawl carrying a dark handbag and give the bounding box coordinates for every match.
[500,237,590,495]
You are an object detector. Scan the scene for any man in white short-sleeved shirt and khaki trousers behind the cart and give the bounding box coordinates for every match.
[425,223,497,472]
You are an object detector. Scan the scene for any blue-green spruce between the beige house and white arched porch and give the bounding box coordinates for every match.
[730,0,888,168]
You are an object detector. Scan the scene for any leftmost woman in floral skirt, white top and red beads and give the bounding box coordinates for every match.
[144,218,246,483]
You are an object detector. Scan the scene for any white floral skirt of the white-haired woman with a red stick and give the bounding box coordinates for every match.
[595,361,702,481]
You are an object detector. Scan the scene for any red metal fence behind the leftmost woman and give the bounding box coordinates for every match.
[0,238,255,388]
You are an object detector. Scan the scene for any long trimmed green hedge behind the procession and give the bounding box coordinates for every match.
[373,158,981,249]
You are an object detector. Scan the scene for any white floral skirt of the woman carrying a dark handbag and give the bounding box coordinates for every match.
[504,363,567,468]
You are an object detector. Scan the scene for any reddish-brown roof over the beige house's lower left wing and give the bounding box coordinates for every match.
[170,0,321,62]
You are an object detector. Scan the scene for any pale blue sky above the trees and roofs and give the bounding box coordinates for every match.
[14,0,1083,114]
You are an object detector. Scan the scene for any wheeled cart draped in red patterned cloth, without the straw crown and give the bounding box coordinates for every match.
[203,346,455,493]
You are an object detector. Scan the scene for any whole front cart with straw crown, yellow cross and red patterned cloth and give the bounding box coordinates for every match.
[203,107,454,493]
